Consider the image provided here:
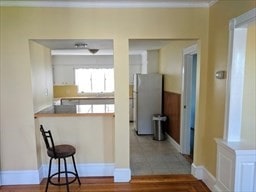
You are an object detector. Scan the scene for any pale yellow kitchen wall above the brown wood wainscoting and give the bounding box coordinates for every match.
[159,40,197,94]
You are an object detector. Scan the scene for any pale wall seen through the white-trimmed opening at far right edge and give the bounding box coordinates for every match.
[241,22,256,146]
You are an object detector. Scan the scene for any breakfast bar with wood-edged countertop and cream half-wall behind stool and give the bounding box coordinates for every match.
[35,104,115,172]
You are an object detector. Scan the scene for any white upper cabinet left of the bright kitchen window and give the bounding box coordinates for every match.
[53,66,75,85]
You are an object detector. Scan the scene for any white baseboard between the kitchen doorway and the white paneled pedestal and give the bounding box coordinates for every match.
[191,164,216,191]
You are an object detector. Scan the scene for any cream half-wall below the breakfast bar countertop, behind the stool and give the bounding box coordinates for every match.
[36,114,114,164]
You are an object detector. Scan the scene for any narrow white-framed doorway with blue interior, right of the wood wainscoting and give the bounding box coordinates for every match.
[181,45,197,161]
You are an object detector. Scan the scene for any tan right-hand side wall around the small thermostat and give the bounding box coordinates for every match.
[206,0,256,175]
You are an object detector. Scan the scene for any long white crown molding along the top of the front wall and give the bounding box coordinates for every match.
[0,0,218,8]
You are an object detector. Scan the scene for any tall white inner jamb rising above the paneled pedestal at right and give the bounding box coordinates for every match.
[226,28,247,141]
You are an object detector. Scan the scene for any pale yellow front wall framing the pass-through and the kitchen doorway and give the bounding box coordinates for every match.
[1,7,209,170]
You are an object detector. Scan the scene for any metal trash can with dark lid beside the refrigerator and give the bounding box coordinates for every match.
[153,114,167,141]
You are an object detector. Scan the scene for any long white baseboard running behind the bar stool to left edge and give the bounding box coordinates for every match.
[0,163,114,185]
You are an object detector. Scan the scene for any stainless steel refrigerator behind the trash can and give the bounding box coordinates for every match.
[133,74,162,135]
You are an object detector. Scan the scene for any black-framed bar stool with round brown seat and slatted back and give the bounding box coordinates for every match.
[40,125,81,192]
